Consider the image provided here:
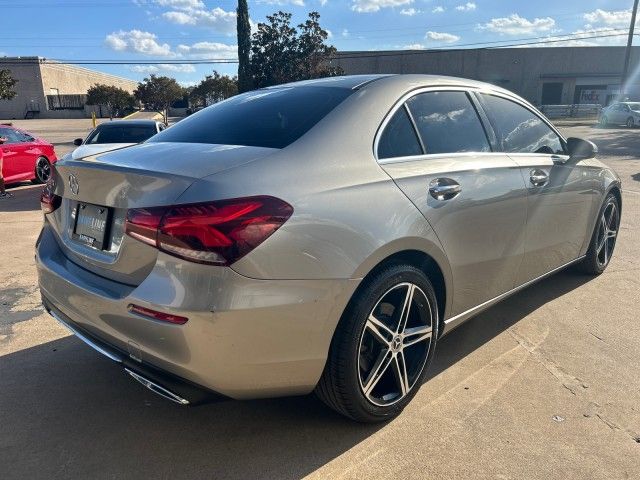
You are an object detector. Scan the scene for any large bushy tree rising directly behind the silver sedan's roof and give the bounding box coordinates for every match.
[251,12,342,88]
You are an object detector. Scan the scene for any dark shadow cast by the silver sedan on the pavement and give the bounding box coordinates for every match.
[0,273,588,480]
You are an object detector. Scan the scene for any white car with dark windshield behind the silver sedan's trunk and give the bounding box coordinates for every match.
[64,120,166,160]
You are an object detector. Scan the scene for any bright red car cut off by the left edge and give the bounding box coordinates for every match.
[0,124,58,183]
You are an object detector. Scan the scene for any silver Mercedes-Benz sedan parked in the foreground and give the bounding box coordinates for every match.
[36,75,621,422]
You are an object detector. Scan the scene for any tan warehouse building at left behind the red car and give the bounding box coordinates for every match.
[0,57,138,120]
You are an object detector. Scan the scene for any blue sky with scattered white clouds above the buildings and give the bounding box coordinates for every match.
[0,0,633,85]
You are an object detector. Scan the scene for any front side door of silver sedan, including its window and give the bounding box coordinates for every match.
[478,93,594,284]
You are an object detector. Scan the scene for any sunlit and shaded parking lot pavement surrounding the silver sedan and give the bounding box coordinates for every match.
[0,124,640,479]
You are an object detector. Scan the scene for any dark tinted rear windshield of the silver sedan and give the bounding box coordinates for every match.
[149,87,353,148]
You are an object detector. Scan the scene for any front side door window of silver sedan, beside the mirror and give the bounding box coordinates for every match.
[482,95,564,154]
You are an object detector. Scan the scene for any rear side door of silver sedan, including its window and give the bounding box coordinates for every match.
[377,88,527,315]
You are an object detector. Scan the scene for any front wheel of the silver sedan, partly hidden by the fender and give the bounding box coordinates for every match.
[577,193,620,275]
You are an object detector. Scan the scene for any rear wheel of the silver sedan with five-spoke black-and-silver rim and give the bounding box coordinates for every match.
[316,264,438,423]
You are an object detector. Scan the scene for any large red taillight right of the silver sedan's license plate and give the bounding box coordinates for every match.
[125,196,293,265]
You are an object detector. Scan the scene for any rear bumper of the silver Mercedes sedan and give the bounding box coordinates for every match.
[36,222,359,400]
